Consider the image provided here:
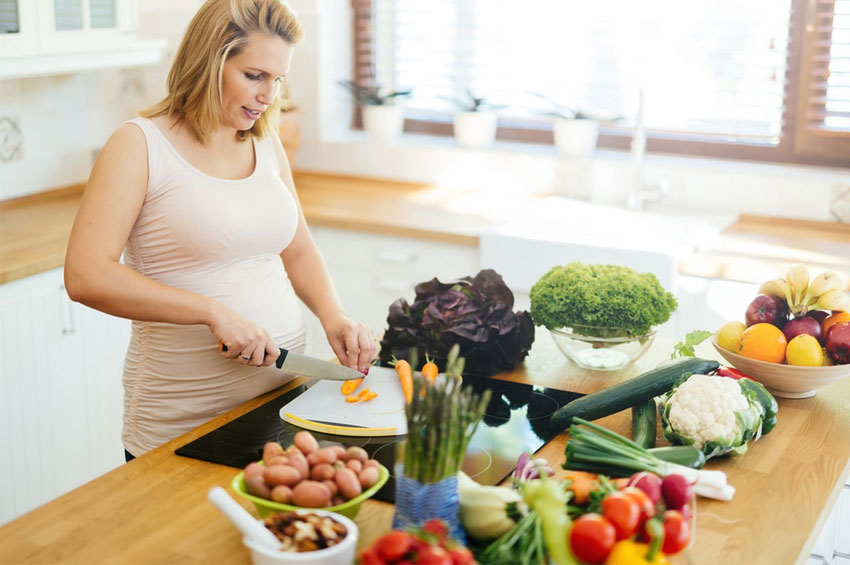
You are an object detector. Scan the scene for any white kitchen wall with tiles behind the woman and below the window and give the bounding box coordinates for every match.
[0,0,850,222]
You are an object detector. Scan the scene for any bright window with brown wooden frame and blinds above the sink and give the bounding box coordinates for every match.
[352,0,850,166]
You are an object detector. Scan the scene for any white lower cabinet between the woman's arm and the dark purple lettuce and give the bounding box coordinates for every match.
[307,226,479,357]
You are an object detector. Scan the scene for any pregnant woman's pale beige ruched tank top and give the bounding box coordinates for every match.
[123,118,306,456]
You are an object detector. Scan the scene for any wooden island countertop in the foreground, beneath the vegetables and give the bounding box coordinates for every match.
[0,331,850,565]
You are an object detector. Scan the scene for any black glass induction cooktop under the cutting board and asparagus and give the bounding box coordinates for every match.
[175,377,582,502]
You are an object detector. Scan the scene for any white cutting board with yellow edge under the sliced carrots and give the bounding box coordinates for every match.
[280,367,407,437]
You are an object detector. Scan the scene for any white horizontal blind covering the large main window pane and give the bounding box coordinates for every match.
[368,0,792,145]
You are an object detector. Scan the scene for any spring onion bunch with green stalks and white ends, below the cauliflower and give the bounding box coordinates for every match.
[564,418,735,500]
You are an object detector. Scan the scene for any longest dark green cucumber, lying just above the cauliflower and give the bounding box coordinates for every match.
[549,357,720,431]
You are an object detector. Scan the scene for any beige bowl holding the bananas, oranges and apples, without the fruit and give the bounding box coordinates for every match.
[711,335,850,398]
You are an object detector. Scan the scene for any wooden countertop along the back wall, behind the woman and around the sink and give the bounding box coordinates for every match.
[0,172,850,288]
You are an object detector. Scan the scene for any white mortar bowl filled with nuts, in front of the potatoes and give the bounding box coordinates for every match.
[242,509,358,565]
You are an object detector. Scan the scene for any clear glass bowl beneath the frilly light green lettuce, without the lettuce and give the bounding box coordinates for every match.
[549,326,656,371]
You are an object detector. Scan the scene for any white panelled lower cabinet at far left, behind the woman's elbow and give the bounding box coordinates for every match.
[0,269,130,523]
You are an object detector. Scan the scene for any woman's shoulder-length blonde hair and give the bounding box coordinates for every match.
[139,0,304,143]
